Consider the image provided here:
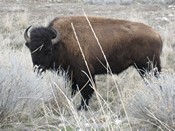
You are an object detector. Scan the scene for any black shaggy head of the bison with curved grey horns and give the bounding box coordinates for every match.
[24,26,60,71]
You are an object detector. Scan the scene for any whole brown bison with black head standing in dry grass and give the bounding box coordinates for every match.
[24,16,163,110]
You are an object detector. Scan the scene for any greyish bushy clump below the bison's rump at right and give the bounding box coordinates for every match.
[126,73,175,130]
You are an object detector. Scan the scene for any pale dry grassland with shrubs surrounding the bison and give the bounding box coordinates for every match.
[0,0,175,131]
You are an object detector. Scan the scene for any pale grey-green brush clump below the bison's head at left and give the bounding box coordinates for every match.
[0,49,68,127]
